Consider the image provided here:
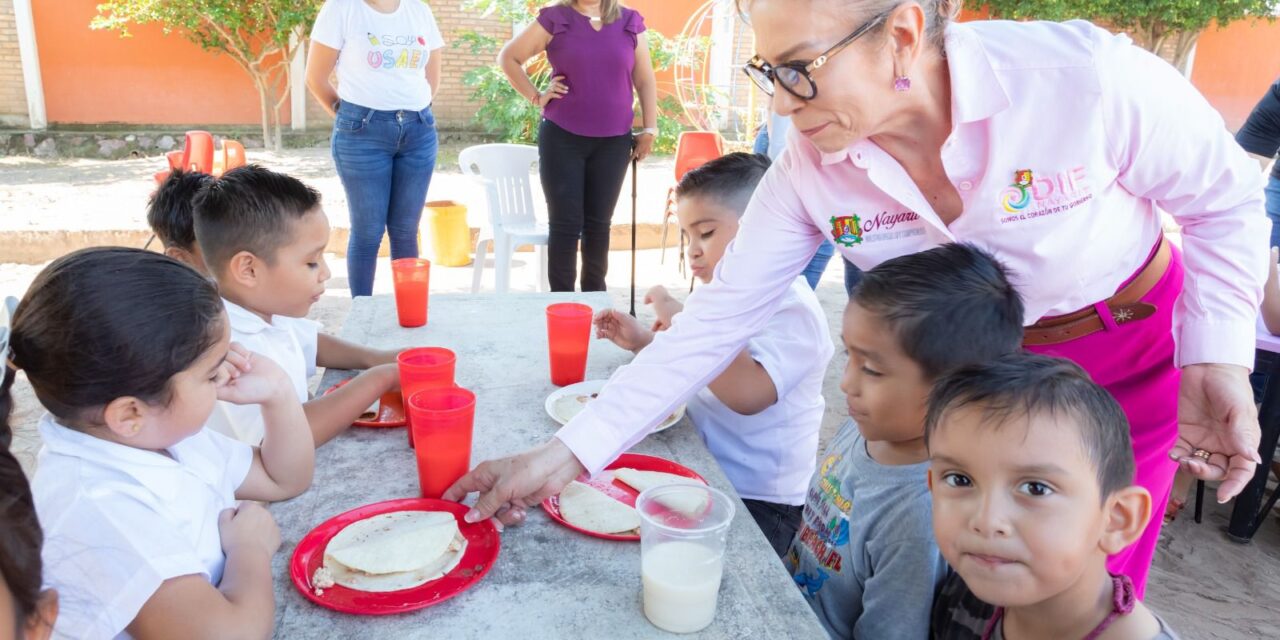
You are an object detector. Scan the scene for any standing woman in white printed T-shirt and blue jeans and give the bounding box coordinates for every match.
[307,0,444,297]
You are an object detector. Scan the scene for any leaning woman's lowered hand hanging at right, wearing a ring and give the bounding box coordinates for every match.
[1169,364,1262,503]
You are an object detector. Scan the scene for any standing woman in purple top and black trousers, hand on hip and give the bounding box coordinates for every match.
[498,0,658,291]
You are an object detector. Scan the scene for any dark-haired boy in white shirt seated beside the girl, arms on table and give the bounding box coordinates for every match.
[193,165,399,447]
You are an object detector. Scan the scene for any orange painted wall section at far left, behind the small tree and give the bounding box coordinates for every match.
[32,0,282,124]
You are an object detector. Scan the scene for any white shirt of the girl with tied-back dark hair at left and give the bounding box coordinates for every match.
[32,413,253,640]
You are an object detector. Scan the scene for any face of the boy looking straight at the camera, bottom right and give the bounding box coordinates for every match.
[929,407,1116,607]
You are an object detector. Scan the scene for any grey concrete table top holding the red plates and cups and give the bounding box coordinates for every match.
[271,293,826,640]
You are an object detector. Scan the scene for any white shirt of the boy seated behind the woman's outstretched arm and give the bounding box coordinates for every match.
[677,278,836,506]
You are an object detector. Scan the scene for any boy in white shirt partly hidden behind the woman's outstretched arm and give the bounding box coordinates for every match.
[595,154,835,557]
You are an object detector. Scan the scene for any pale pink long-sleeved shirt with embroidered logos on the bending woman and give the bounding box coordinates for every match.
[557,20,1270,472]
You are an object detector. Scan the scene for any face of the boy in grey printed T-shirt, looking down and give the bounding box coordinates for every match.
[840,302,933,442]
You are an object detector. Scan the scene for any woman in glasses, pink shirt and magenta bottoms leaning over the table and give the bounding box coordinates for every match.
[447,0,1267,593]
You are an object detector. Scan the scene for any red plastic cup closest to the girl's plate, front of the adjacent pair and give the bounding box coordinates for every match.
[408,387,476,499]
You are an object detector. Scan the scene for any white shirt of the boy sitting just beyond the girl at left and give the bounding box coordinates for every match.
[207,298,320,447]
